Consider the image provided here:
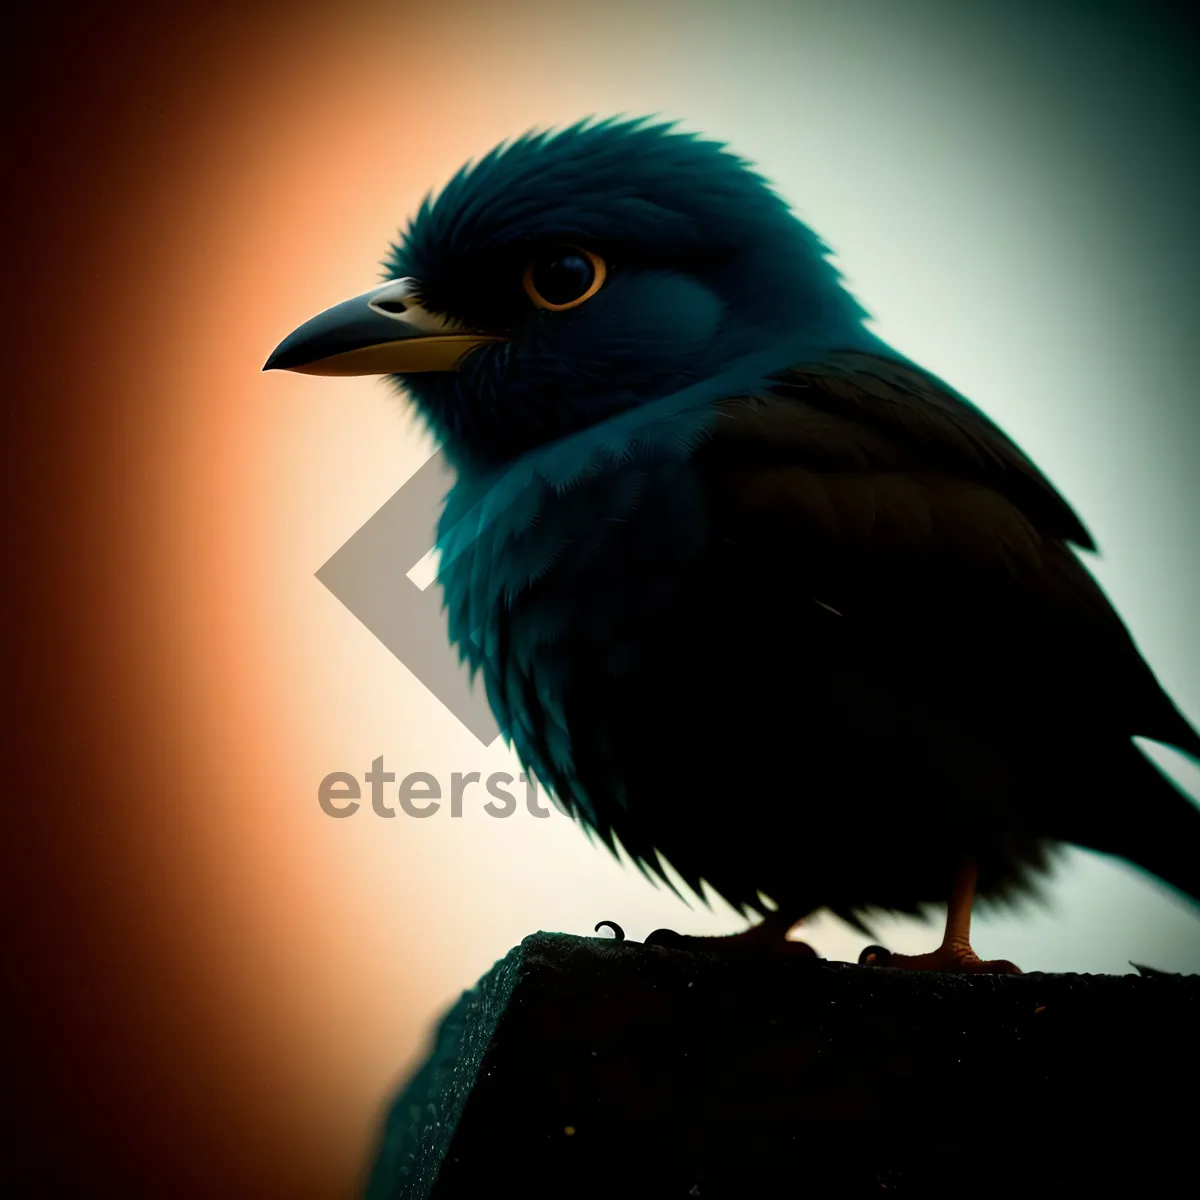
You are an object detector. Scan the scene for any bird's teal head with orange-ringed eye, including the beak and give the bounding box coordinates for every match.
[266,120,864,464]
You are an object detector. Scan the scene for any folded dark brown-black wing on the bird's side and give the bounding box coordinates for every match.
[700,353,1200,754]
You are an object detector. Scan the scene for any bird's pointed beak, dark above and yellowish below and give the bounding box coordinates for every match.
[263,278,508,376]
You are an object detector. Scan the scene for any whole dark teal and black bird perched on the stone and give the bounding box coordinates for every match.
[264,115,1200,973]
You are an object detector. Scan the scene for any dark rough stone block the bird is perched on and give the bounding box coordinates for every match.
[367,934,1200,1200]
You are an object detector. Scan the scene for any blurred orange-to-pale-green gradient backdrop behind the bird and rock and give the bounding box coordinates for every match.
[9,0,1200,1198]
